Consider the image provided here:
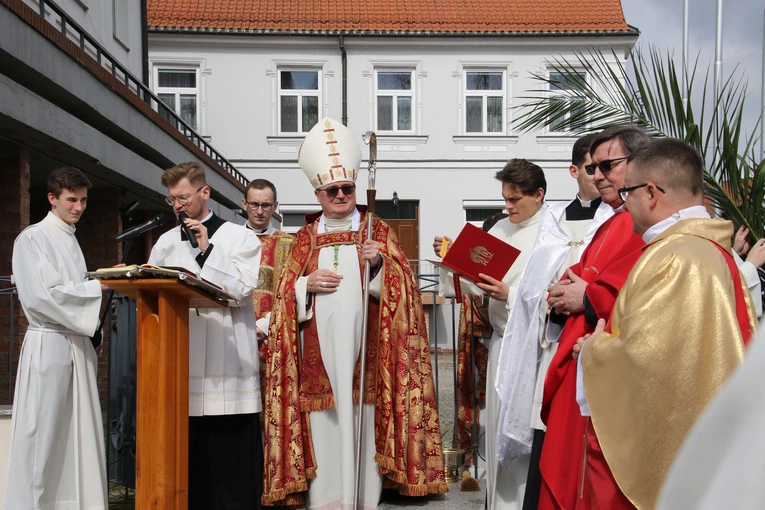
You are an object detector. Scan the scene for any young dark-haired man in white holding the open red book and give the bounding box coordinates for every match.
[433,159,547,510]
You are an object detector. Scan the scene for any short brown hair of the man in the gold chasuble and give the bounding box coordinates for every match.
[627,138,704,197]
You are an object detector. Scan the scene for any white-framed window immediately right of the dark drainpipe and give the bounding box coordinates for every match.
[375,71,414,133]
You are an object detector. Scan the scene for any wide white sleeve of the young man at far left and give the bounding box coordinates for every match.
[13,232,101,336]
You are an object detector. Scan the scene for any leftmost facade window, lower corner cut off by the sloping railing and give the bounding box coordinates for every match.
[155,69,199,131]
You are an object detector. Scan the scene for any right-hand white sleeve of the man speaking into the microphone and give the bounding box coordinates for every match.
[199,231,261,306]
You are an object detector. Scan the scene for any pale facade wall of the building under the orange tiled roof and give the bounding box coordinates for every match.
[149,33,635,258]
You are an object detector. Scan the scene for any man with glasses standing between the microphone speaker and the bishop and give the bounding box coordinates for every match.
[242,179,292,418]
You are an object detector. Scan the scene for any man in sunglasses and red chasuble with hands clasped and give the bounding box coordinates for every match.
[539,126,650,510]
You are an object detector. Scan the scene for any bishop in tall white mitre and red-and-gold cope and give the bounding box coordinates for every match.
[263,119,447,508]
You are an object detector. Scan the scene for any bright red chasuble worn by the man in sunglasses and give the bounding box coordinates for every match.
[539,212,645,510]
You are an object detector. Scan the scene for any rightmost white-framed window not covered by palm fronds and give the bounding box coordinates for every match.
[465,71,506,134]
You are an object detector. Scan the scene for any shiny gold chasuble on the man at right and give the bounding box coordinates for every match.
[582,219,756,509]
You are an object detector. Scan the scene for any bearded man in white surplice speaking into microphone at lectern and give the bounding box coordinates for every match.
[149,163,263,510]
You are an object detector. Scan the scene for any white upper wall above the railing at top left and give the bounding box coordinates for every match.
[24,0,143,80]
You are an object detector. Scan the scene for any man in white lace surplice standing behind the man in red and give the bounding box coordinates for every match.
[487,135,613,509]
